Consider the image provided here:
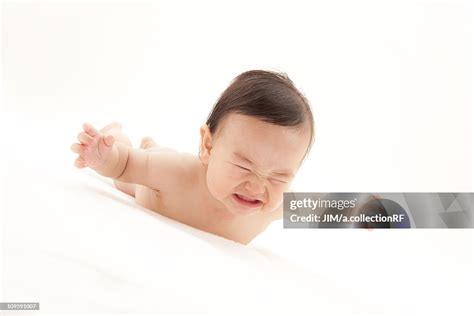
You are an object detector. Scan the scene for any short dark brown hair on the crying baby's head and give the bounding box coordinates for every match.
[206,70,314,156]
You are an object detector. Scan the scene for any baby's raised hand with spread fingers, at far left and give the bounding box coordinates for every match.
[71,123,115,169]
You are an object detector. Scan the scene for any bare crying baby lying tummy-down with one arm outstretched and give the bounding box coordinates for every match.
[71,70,314,244]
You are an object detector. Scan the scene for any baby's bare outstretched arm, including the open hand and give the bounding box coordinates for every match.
[71,123,189,190]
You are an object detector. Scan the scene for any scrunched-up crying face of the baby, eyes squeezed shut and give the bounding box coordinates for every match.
[201,113,310,215]
